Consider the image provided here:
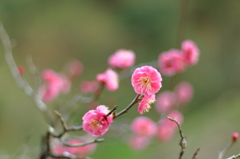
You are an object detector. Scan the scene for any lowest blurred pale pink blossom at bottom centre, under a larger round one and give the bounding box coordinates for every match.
[129,135,149,150]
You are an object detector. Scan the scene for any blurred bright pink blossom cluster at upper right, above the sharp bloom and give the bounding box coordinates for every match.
[158,40,200,76]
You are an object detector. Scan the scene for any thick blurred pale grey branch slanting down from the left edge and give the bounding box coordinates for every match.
[0,22,47,113]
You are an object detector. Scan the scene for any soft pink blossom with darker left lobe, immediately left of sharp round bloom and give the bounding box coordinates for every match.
[97,68,118,91]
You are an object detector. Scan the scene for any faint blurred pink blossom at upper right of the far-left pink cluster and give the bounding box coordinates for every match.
[68,60,83,78]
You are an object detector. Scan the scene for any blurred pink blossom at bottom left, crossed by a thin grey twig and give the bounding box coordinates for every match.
[66,140,96,157]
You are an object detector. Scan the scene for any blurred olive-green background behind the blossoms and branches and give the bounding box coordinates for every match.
[0,0,240,159]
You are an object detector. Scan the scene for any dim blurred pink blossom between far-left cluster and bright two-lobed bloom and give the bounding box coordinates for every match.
[80,81,99,93]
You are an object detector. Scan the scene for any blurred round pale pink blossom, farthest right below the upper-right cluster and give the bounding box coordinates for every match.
[174,82,193,104]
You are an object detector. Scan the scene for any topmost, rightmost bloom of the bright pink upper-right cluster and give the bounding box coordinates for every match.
[182,40,200,66]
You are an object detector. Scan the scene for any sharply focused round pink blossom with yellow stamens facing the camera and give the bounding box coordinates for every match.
[131,66,162,96]
